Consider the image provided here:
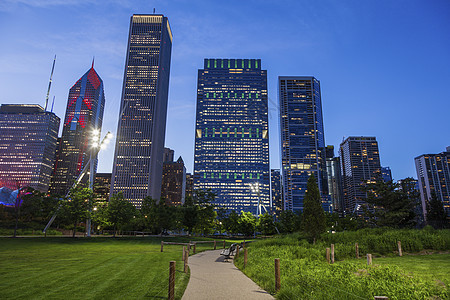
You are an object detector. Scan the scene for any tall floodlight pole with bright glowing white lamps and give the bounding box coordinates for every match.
[86,129,112,237]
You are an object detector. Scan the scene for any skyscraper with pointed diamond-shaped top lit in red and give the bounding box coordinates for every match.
[50,63,105,195]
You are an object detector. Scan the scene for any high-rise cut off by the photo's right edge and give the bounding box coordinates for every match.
[414,147,450,219]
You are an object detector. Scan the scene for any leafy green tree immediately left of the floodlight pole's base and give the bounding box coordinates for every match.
[60,184,94,237]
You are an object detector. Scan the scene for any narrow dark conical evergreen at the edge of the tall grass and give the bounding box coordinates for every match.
[303,175,326,241]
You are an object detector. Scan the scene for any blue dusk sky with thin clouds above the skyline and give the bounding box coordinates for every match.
[0,0,450,179]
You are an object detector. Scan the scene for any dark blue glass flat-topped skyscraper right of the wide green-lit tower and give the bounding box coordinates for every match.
[278,76,329,212]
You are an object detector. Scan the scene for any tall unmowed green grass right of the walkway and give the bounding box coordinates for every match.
[236,230,450,299]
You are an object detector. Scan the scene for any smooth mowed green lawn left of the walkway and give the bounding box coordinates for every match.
[0,237,225,299]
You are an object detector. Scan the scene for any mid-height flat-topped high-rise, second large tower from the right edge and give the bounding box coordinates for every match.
[339,136,381,215]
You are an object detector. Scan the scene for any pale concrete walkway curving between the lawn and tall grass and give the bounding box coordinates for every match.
[182,250,275,300]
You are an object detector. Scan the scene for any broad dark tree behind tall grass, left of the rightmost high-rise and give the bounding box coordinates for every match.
[364,178,419,228]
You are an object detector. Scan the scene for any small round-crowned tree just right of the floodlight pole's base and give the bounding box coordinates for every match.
[106,192,136,237]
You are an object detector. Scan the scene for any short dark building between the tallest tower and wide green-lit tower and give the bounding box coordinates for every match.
[161,156,186,205]
